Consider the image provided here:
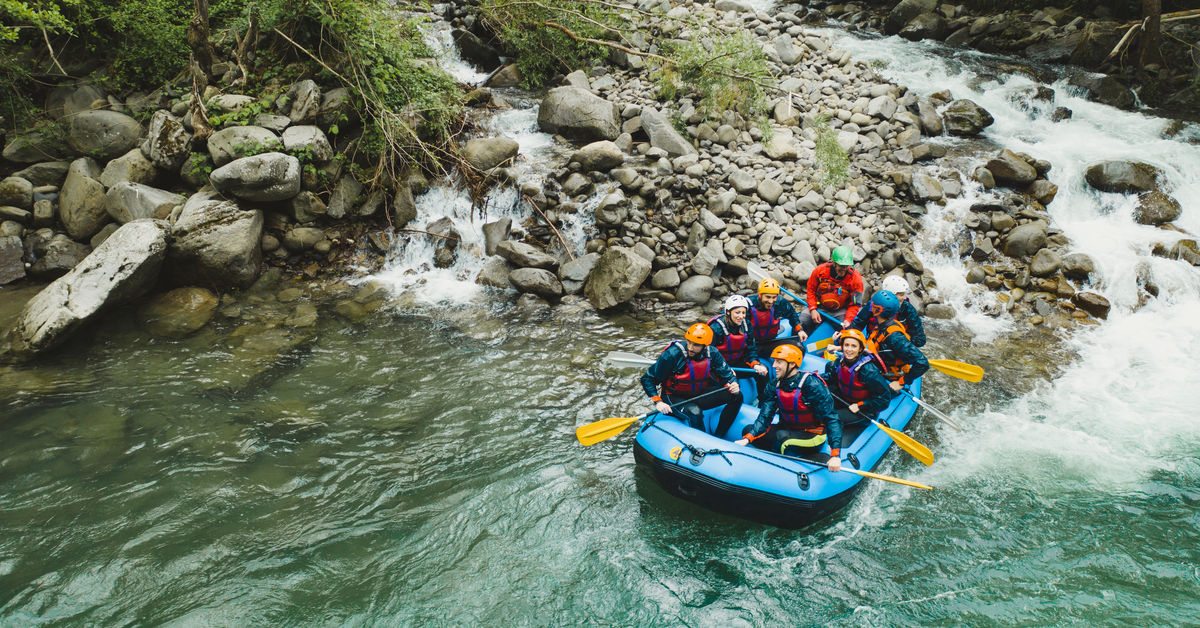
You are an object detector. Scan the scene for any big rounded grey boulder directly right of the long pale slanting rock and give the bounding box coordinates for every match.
[168,192,263,287]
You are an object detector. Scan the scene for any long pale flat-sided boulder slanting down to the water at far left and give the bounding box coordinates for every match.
[12,221,167,357]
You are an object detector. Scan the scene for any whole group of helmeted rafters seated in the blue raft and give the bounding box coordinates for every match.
[642,246,929,471]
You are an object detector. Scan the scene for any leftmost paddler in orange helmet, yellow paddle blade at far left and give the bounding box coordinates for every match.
[642,323,742,438]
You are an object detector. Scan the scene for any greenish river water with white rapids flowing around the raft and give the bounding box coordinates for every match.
[0,19,1200,626]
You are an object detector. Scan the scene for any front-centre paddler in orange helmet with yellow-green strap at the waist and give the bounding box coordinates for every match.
[737,345,841,471]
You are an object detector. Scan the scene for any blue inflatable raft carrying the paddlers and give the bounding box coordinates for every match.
[634,324,920,528]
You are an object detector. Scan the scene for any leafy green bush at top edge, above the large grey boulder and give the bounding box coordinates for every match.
[480,0,623,88]
